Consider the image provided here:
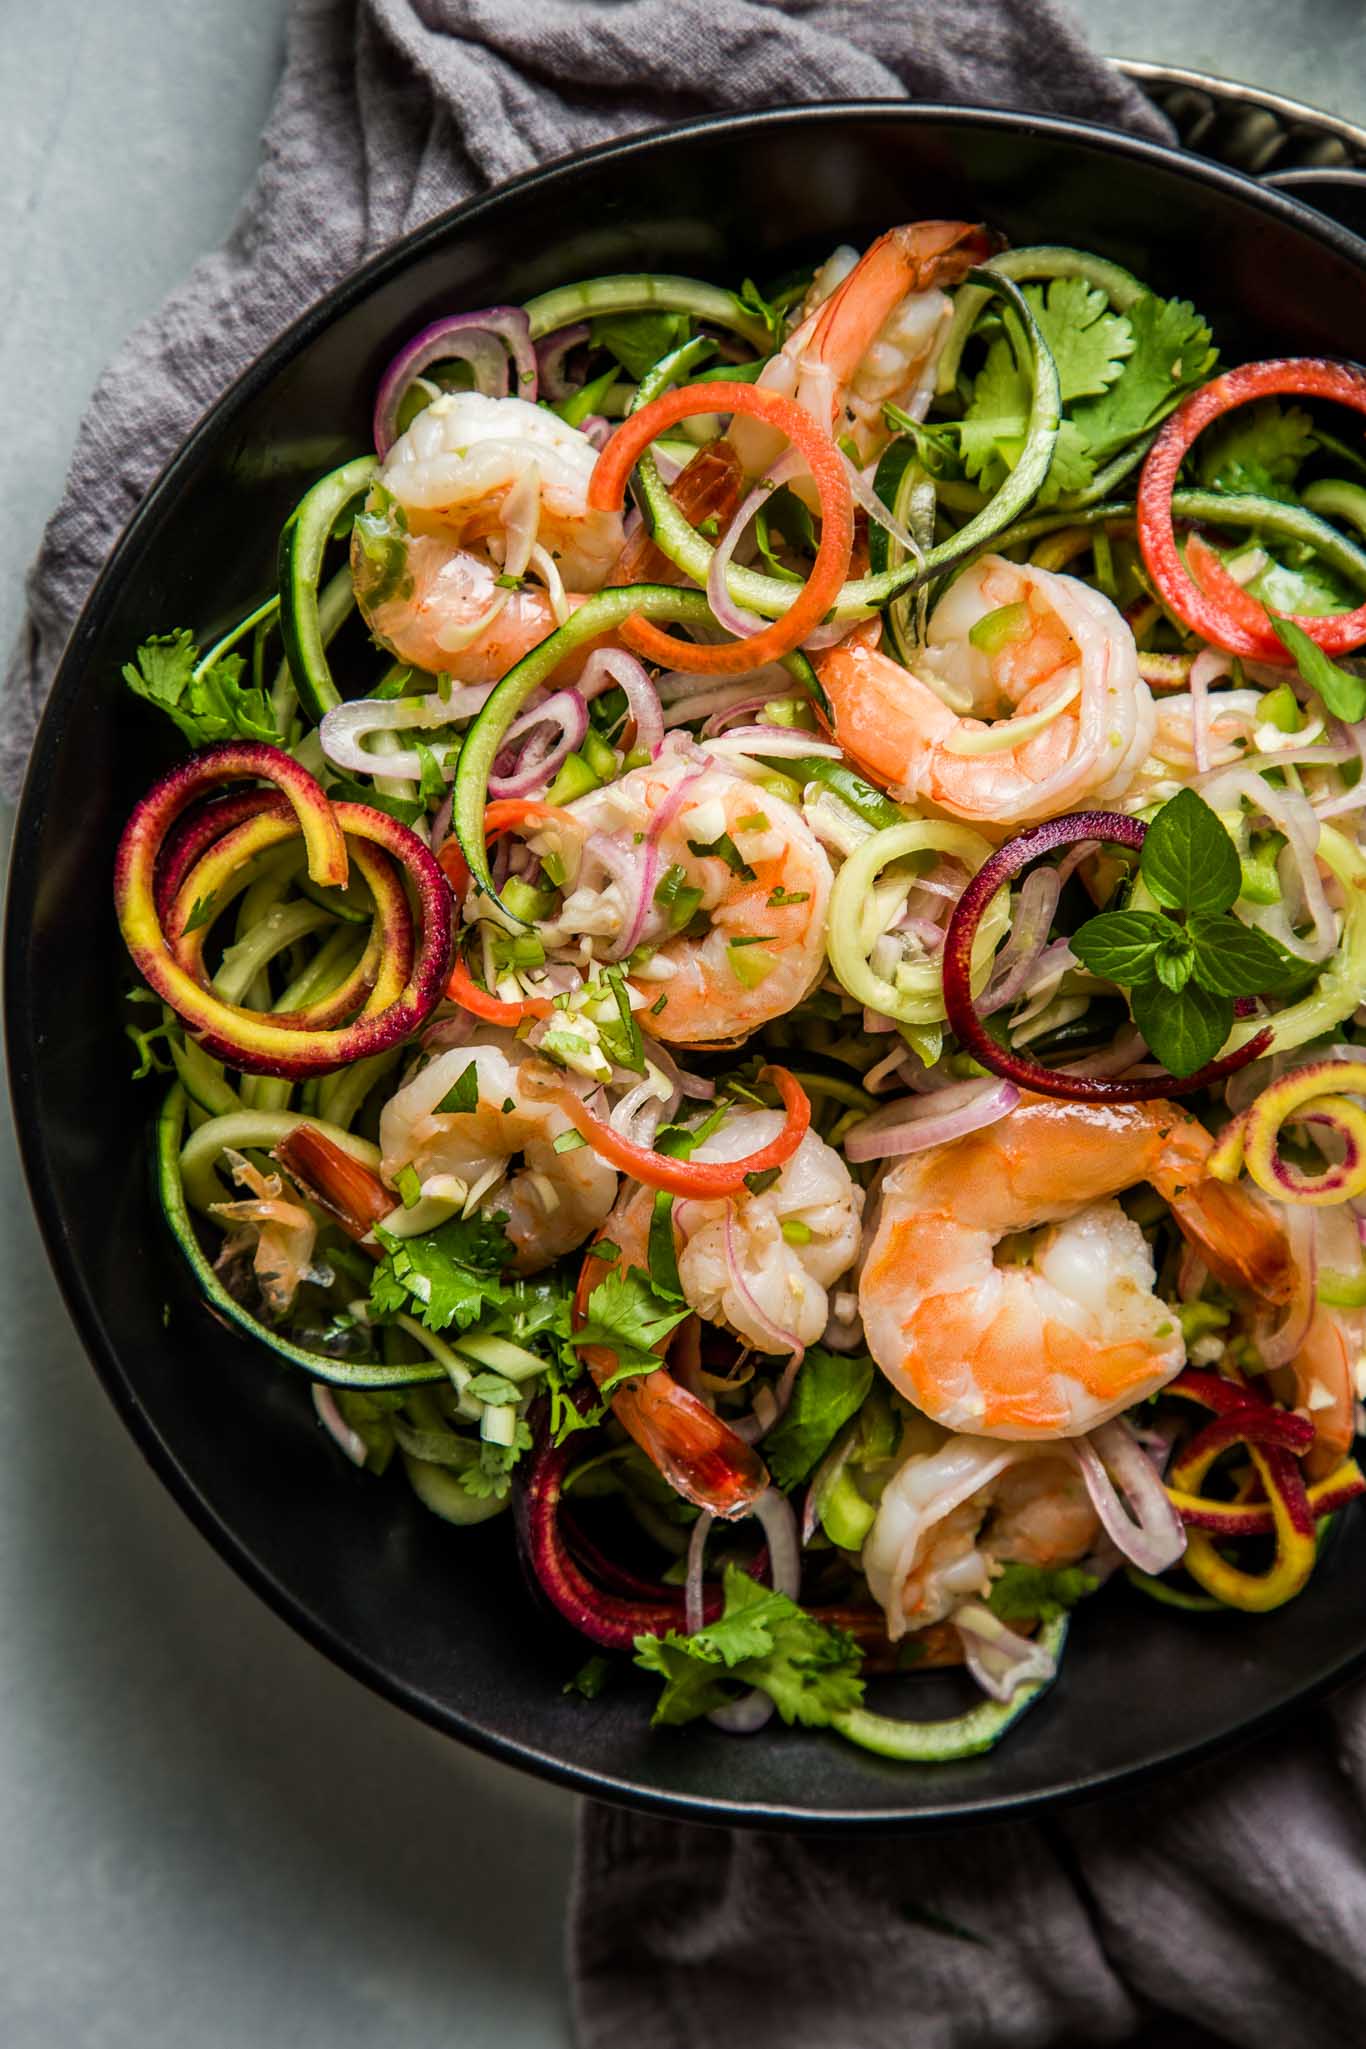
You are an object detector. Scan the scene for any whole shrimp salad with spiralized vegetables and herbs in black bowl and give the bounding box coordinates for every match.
[115,221,1366,1762]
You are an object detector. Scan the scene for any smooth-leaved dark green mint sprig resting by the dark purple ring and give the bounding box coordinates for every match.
[1071,789,1303,1076]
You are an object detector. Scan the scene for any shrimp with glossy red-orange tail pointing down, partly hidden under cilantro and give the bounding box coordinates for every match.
[575,1188,768,1518]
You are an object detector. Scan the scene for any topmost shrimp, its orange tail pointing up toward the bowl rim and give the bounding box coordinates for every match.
[731,221,993,475]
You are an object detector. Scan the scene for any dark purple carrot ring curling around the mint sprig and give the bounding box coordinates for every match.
[944,811,1272,1102]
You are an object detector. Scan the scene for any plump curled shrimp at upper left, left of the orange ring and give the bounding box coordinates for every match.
[350,391,623,682]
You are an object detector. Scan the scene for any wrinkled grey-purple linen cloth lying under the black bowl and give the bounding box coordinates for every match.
[10,0,1366,2049]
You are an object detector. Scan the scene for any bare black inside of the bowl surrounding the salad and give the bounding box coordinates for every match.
[6,104,1366,1828]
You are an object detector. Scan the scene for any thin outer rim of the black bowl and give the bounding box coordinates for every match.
[4,100,1366,1836]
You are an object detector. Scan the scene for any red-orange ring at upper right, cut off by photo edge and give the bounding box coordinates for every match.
[1139,357,1366,664]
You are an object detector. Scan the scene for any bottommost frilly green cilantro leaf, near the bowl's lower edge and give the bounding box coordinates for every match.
[635,1565,862,1727]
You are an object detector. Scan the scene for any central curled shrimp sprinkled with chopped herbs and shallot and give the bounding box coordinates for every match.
[553,754,834,1045]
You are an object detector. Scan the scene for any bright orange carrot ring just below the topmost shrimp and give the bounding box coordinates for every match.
[588,383,854,676]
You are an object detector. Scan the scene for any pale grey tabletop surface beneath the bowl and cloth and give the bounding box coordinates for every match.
[0,0,1366,2049]
